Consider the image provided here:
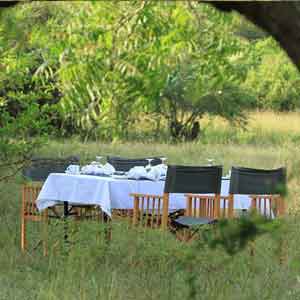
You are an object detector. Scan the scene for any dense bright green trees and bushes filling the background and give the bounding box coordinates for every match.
[0,1,300,149]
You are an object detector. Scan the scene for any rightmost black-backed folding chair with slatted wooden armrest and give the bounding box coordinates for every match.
[229,167,286,218]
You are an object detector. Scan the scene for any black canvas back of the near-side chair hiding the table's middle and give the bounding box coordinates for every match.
[164,166,222,194]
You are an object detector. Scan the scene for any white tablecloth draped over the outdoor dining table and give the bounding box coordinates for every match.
[36,173,251,216]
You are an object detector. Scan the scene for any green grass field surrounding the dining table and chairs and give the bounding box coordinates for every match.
[0,113,300,300]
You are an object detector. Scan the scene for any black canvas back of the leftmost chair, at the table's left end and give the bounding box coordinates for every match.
[22,157,79,181]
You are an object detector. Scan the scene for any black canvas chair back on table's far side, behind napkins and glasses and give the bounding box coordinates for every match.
[107,156,162,172]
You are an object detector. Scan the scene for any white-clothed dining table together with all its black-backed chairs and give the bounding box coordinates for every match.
[21,156,286,255]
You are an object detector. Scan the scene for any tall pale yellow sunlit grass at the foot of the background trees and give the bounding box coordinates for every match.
[128,111,300,145]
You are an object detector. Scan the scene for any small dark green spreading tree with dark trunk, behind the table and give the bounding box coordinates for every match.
[160,63,253,140]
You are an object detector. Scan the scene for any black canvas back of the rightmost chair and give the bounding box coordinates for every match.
[229,167,286,195]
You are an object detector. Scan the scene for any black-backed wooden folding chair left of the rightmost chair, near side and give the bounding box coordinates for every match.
[132,166,222,238]
